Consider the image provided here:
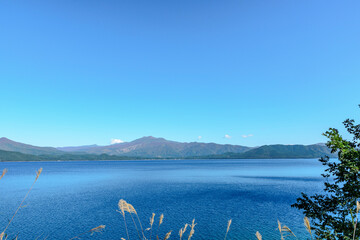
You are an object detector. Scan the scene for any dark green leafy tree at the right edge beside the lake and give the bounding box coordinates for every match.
[292,105,360,239]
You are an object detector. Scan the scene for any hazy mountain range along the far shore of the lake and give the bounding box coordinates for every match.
[0,137,336,161]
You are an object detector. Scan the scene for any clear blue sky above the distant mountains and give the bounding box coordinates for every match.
[0,0,360,146]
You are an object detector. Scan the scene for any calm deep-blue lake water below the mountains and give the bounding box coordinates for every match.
[0,159,323,240]
